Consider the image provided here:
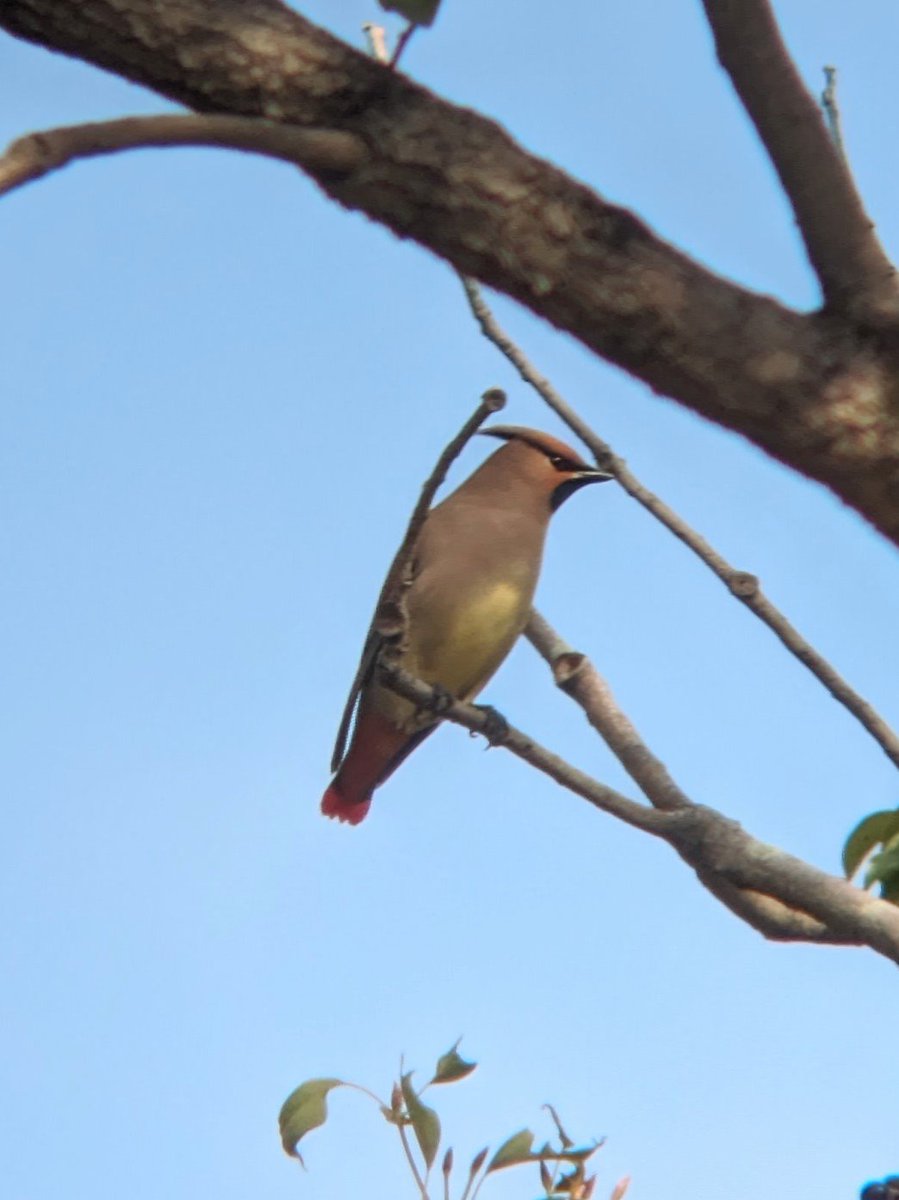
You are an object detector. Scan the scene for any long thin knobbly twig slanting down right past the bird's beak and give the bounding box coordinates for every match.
[460,276,899,767]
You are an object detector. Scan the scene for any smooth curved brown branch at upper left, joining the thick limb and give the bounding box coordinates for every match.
[0,114,366,196]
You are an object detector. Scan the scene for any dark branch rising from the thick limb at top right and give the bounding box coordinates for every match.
[703,0,899,326]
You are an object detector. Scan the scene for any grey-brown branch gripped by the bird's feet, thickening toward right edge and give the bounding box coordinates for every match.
[379,665,899,965]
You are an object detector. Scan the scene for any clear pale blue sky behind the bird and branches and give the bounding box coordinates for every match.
[0,7,899,1200]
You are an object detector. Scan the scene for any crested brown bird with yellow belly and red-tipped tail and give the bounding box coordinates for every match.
[322,425,612,824]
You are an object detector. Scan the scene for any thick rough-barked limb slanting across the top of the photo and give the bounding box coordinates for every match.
[0,0,899,542]
